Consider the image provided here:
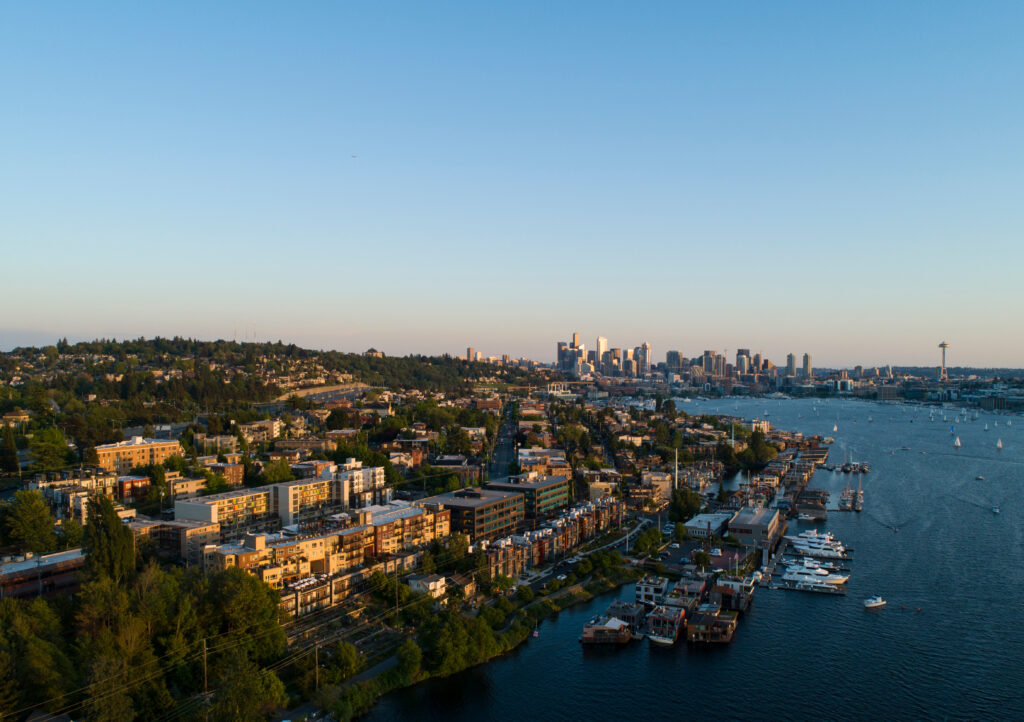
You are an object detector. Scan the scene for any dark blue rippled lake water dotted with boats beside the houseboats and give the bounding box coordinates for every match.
[369,399,1024,722]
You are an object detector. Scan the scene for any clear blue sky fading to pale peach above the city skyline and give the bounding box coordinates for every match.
[0,0,1024,367]
